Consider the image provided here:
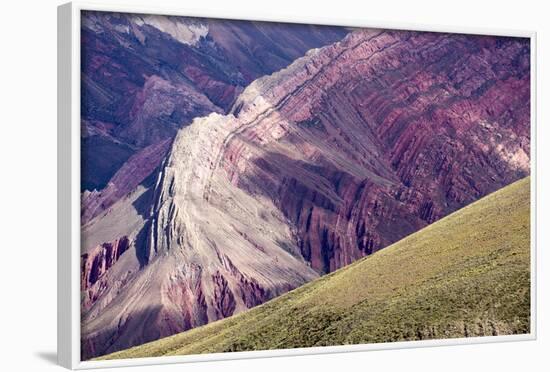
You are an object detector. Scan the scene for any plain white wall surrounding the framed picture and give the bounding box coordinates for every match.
[0,0,550,372]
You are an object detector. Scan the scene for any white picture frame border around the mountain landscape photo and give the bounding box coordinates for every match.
[57,1,537,369]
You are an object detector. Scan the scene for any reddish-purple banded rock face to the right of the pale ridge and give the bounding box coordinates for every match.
[220,31,530,272]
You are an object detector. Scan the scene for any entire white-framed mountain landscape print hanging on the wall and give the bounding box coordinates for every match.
[58,3,536,368]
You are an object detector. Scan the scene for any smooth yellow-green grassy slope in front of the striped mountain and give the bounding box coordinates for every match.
[102,178,530,359]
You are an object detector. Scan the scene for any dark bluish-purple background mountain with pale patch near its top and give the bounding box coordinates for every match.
[81,11,348,203]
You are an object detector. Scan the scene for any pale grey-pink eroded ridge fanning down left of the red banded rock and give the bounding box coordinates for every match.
[82,114,318,357]
